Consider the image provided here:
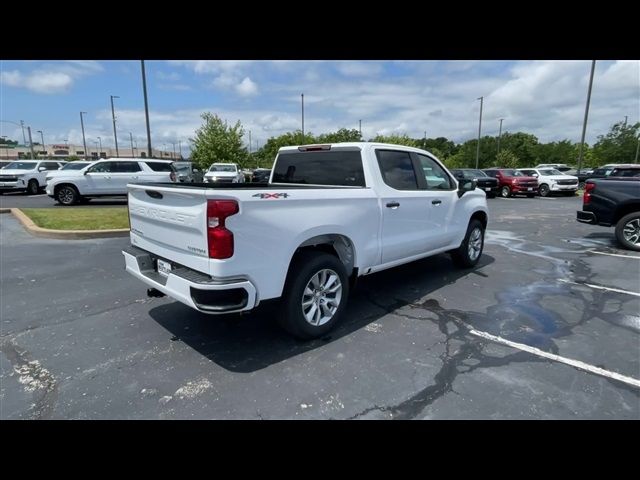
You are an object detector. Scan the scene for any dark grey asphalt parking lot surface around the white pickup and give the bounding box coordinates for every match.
[0,197,640,419]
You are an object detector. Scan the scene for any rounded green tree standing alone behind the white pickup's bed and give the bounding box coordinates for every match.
[190,112,251,169]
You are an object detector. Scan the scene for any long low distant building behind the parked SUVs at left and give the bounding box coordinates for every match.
[0,143,183,161]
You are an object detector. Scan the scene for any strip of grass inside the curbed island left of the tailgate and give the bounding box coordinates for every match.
[20,207,129,230]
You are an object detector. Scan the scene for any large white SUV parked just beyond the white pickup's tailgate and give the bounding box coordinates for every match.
[47,158,177,205]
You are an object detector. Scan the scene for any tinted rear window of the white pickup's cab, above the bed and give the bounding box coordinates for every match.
[273,151,365,187]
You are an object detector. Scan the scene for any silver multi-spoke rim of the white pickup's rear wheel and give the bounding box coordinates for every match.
[302,268,342,327]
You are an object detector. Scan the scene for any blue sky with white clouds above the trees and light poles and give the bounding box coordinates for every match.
[0,60,640,153]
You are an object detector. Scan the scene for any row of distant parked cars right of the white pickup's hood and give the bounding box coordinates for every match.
[451,164,640,198]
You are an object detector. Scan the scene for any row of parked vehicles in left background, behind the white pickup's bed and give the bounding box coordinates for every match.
[0,158,271,205]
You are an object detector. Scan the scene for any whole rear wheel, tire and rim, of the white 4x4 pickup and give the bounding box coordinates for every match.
[278,251,349,340]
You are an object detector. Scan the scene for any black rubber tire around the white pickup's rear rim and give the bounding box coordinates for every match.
[278,251,349,340]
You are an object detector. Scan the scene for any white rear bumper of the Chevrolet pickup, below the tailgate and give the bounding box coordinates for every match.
[122,246,257,314]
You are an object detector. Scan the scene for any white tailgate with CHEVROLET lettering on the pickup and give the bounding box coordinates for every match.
[128,184,209,273]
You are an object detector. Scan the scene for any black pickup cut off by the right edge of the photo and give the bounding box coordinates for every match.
[577,177,640,251]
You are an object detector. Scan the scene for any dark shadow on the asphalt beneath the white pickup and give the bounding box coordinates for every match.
[149,254,495,373]
